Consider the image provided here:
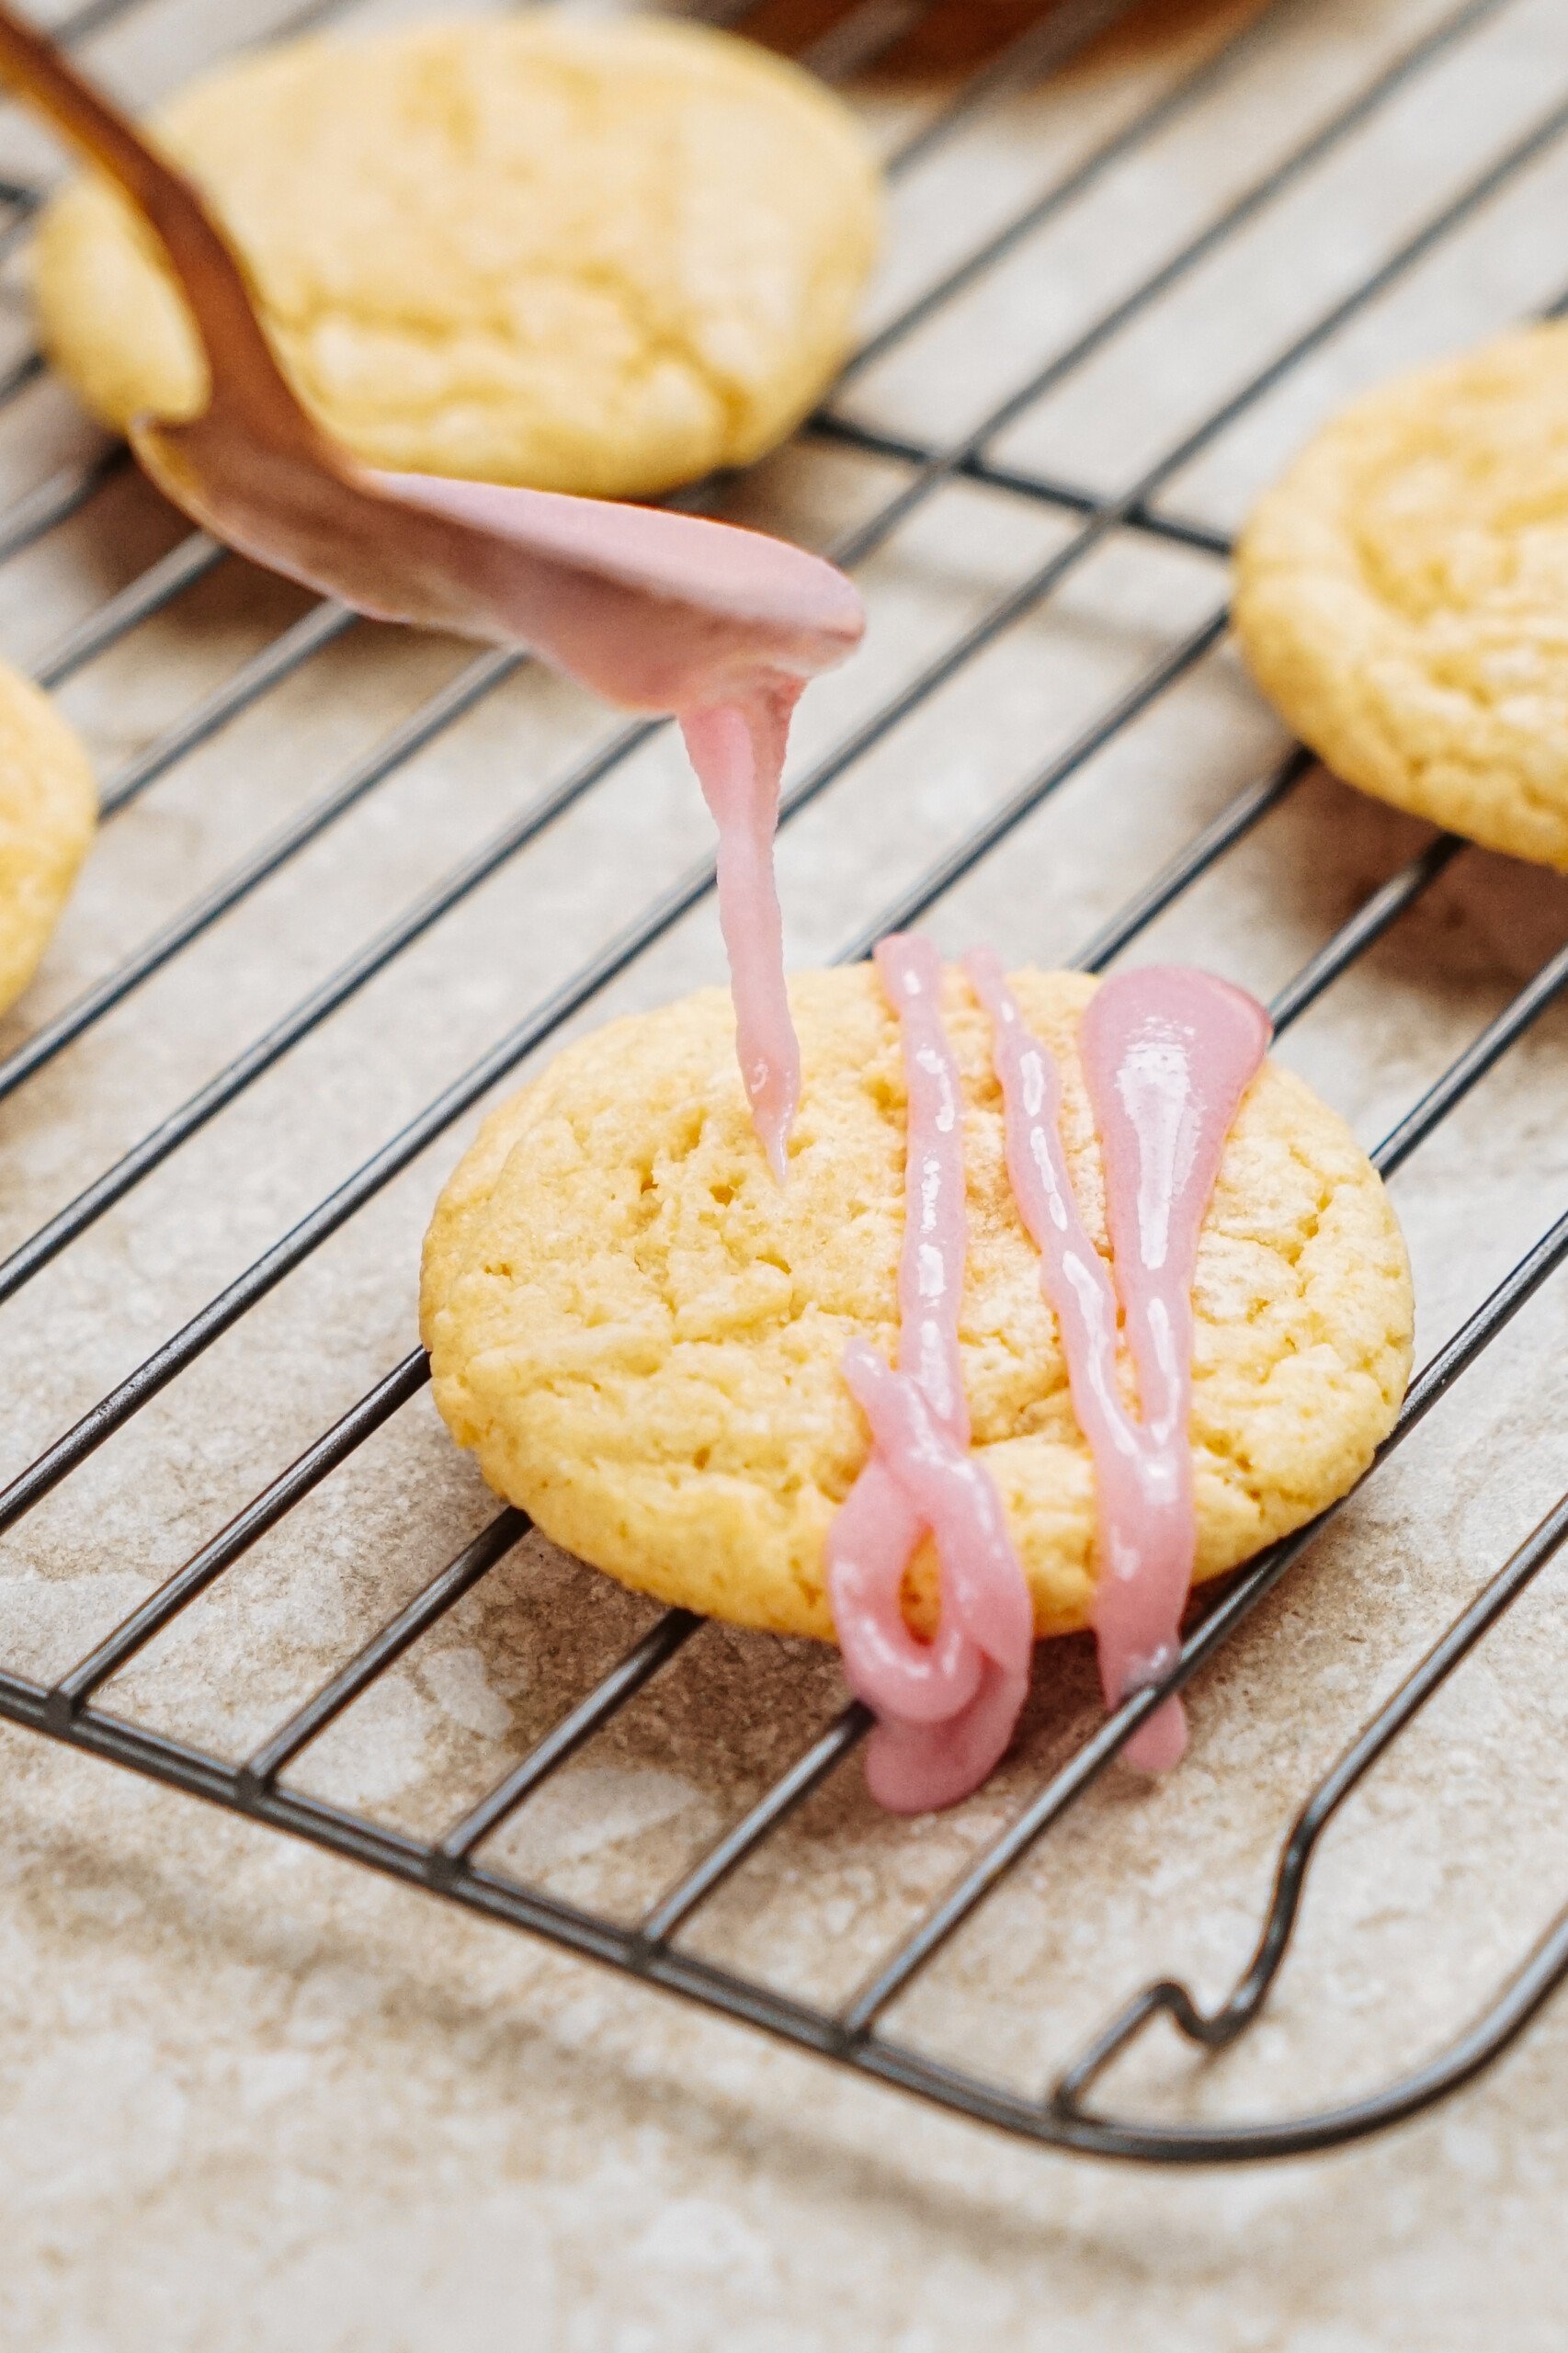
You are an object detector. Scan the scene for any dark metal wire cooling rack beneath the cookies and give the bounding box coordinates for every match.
[0,0,1568,2163]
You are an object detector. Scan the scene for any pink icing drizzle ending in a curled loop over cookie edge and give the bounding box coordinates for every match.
[826,937,1034,1814]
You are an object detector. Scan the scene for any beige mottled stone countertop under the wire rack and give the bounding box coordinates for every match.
[0,0,1568,2353]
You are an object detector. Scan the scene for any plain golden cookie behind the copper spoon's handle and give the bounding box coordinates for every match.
[35,12,881,496]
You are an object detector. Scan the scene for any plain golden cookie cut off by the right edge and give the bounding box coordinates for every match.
[1236,324,1568,869]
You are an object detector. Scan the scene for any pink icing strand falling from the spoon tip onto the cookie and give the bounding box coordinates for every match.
[680,680,802,1184]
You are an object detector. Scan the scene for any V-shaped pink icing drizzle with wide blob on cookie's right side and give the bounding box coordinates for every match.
[968,950,1271,1772]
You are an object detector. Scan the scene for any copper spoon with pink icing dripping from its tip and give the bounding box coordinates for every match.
[0,7,864,1172]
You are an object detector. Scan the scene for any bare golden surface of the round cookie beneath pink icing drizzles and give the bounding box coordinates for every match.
[422,965,1410,1638]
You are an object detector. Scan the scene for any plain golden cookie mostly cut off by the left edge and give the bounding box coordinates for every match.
[0,664,99,1012]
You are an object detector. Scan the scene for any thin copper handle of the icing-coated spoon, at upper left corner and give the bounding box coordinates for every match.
[0,5,320,457]
